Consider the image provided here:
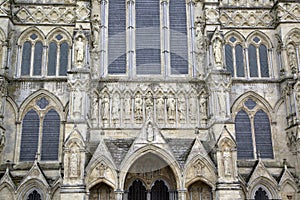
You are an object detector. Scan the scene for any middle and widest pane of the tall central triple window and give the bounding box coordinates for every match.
[136,0,161,74]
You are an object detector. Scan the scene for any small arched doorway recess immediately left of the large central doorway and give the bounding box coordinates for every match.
[89,183,115,200]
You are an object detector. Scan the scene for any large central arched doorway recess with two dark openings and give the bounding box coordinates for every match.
[125,153,177,200]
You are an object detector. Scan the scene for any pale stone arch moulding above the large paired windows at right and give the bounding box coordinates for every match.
[230,91,273,115]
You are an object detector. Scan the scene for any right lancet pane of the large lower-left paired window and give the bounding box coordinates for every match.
[41,110,60,160]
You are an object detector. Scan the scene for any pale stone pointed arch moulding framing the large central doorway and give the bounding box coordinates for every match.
[119,145,181,188]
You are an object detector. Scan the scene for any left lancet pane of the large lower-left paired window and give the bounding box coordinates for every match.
[20,110,40,161]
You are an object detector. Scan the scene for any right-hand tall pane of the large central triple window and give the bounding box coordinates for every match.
[169,0,188,74]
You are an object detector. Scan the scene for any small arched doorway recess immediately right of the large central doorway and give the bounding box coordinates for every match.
[187,181,213,200]
